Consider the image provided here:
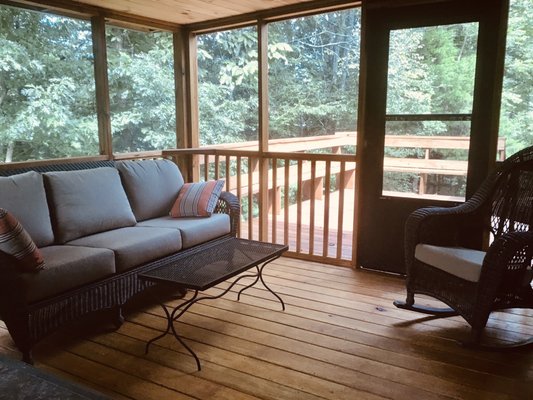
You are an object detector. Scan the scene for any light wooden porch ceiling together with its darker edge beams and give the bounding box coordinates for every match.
[0,0,361,32]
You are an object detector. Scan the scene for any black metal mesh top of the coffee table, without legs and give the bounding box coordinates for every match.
[139,238,287,290]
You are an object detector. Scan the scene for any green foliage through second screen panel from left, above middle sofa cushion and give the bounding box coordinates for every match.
[106,26,176,152]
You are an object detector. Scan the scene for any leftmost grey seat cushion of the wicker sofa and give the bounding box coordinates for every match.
[21,245,115,303]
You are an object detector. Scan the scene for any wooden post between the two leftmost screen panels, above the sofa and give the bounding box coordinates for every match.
[91,17,113,156]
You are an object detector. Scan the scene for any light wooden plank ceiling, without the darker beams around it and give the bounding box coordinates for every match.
[68,0,324,25]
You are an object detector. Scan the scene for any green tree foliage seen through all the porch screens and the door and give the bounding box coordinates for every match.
[0,0,533,161]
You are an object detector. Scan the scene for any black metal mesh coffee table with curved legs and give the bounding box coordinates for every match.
[139,237,288,371]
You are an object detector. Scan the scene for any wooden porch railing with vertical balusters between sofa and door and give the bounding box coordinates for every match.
[163,148,355,266]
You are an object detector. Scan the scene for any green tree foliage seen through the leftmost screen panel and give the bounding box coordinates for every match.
[0,6,98,162]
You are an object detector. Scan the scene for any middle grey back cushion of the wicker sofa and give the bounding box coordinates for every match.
[44,167,136,243]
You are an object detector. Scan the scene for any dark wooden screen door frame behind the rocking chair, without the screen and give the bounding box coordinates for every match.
[355,0,509,273]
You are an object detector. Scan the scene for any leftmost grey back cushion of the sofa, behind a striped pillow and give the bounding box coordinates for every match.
[0,171,54,247]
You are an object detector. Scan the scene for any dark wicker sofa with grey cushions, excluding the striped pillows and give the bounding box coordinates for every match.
[0,160,240,363]
